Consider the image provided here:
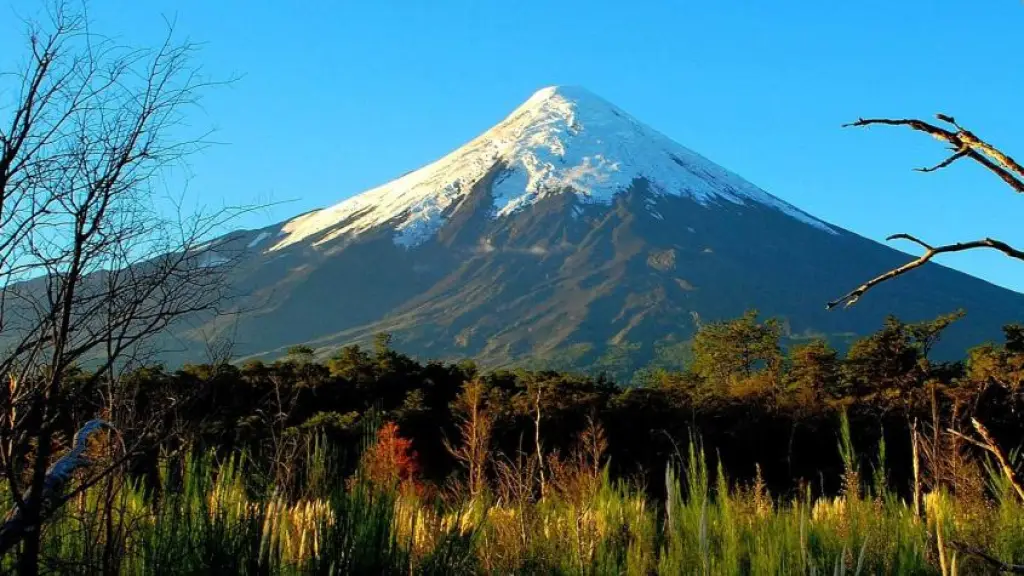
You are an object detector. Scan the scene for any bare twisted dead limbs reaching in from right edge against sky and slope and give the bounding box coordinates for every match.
[827,114,1024,310]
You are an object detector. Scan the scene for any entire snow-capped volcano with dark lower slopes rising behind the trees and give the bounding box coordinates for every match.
[186,86,1024,372]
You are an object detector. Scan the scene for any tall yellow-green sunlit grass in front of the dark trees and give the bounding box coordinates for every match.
[5,416,1024,575]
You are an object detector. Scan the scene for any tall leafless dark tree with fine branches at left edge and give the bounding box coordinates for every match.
[0,1,242,574]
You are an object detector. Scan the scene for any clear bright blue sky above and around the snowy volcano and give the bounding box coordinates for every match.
[6,0,1024,291]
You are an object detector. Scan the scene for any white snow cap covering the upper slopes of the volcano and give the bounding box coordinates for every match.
[270,86,835,250]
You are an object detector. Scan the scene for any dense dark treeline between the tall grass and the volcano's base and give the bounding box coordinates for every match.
[51,313,1024,495]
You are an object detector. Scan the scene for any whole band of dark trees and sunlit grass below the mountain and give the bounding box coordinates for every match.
[3,314,1024,574]
